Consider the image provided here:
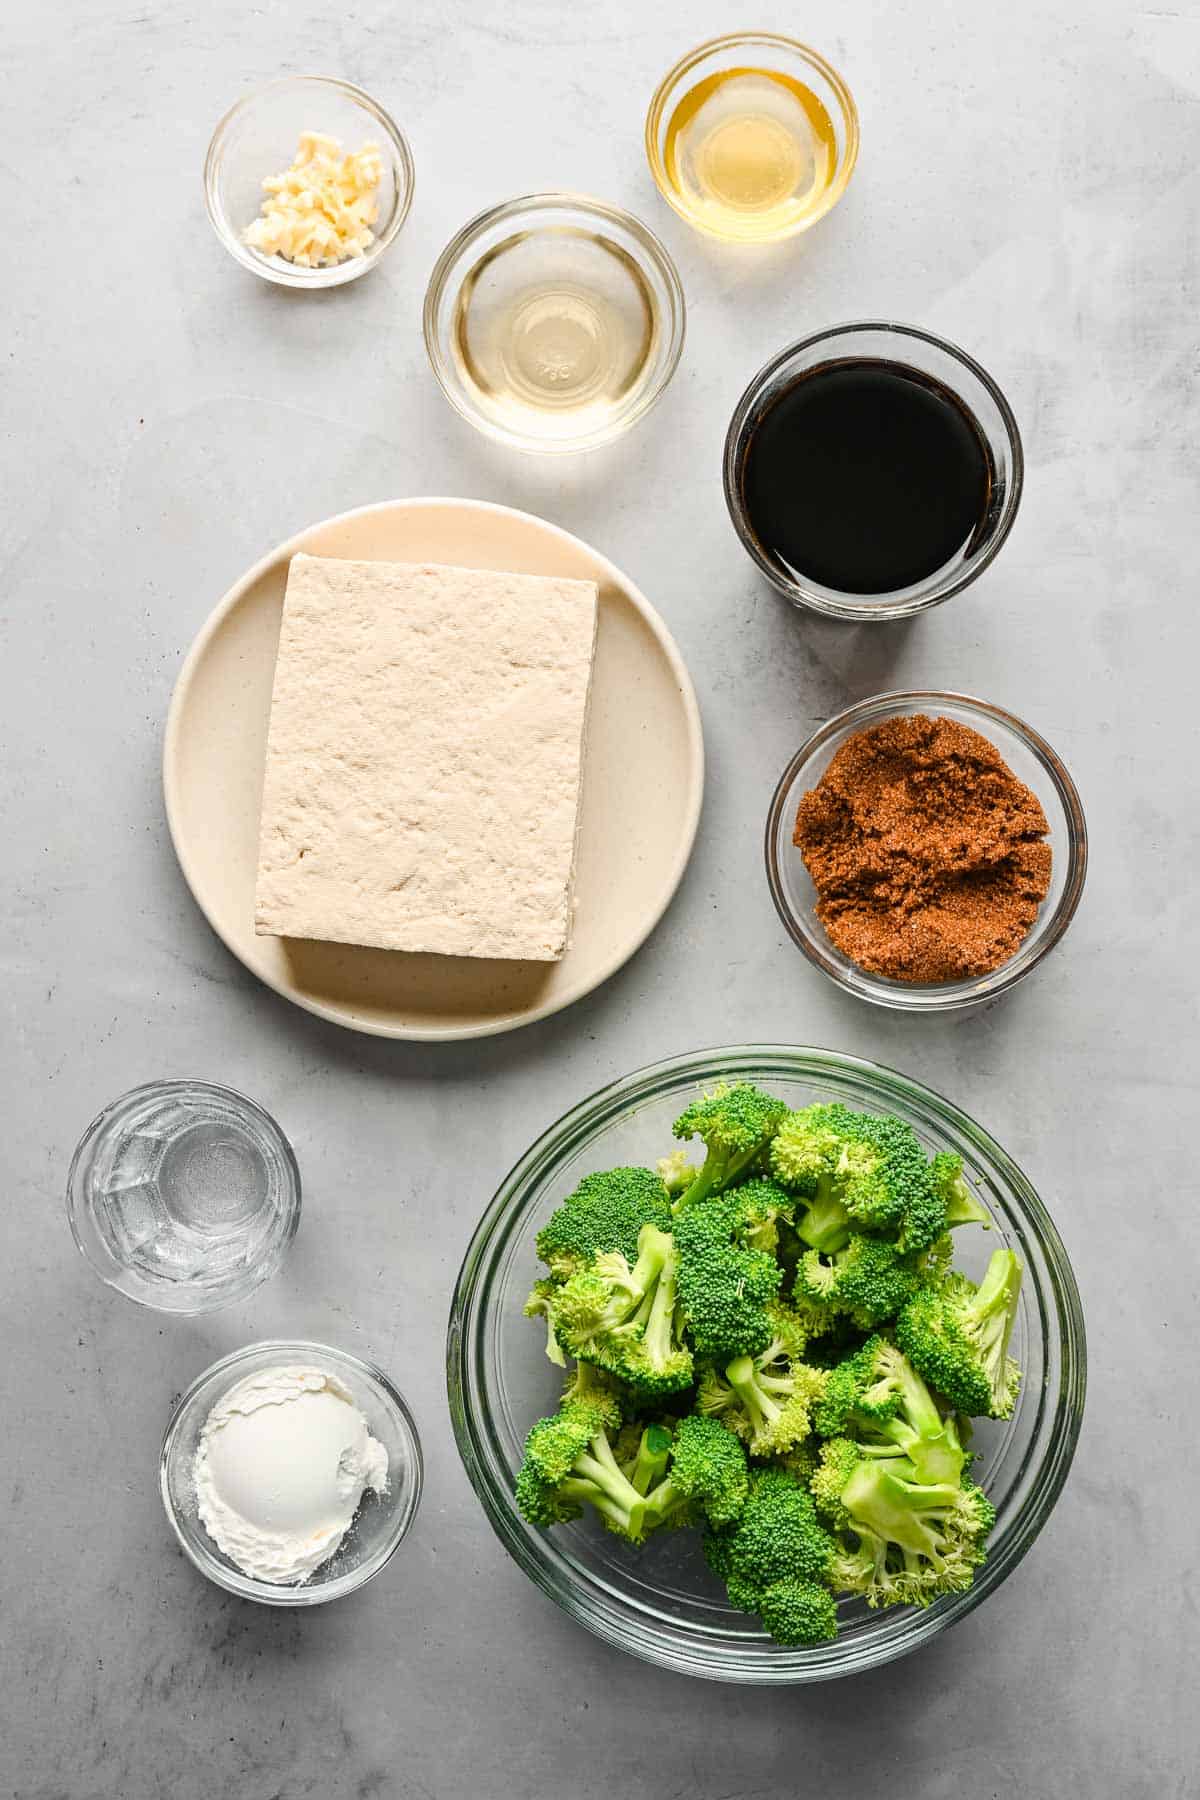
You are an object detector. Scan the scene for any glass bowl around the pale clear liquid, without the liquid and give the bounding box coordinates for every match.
[425,193,685,454]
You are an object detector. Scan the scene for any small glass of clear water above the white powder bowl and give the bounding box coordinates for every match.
[67,1082,300,1312]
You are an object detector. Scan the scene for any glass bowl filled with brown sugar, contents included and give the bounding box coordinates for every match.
[766,693,1087,1012]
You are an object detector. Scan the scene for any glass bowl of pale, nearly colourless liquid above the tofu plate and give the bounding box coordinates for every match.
[425,193,684,452]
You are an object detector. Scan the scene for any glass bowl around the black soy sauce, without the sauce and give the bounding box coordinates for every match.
[725,320,1025,625]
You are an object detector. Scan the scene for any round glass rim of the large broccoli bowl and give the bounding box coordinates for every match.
[446,1044,1087,1687]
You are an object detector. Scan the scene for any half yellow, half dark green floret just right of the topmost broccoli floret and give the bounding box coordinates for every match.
[770,1103,946,1255]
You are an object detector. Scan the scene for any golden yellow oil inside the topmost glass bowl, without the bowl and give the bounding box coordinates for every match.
[664,68,837,239]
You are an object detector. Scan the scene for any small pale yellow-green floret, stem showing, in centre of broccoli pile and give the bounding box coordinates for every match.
[698,1301,828,1456]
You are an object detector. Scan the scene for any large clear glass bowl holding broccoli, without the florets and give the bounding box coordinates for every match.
[448,1044,1085,1687]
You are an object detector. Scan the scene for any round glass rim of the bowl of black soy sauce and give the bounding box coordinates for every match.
[721,319,1025,625]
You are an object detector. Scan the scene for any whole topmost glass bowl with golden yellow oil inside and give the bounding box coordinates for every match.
[646,31,858,243]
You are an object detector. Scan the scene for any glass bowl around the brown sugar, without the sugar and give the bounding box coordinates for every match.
[766,691,1087,1013]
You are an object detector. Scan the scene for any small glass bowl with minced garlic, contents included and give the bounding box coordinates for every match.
[205,76,412,288]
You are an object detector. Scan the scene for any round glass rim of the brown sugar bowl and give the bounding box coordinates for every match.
[763,688,1088,1013]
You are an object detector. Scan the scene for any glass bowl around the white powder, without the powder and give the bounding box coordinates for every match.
[158,1341,423,1606]
